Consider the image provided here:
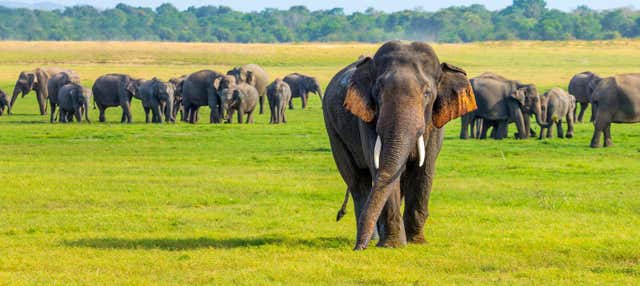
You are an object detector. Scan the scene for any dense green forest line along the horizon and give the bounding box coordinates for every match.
[0,0,640,43]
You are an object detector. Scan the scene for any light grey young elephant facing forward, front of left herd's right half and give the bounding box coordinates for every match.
[220,76,260,123]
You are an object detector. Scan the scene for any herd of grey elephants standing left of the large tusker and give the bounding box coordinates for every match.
[0,64,322,124]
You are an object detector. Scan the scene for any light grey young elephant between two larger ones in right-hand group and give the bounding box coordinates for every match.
[540,87,576,139]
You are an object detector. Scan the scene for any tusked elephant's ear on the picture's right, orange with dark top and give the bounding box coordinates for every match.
[432,63,478,128]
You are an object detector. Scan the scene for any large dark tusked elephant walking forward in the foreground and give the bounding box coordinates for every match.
[322,41,476,250]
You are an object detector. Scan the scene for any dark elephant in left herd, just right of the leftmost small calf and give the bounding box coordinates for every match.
[92,74,144,123]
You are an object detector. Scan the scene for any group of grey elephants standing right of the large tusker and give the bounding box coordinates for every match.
[460,72,640,148]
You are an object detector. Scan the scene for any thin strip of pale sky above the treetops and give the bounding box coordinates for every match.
[10,0,640,13]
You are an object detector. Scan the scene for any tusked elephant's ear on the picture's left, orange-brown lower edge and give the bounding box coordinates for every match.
[344,57,376,123]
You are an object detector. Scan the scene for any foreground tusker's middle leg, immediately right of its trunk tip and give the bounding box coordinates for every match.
[377,188,407,248]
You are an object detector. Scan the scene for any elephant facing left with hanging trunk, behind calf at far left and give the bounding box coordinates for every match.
[8,67,76,115]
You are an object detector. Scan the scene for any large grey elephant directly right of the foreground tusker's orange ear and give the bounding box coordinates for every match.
[460,73,546,139]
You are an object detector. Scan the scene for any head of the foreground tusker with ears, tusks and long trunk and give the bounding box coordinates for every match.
[344,42,477,250]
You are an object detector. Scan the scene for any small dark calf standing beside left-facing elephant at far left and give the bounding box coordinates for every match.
[58,83,92,123]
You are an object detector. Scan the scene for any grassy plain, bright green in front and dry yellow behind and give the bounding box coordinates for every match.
[0,41,640,285]
